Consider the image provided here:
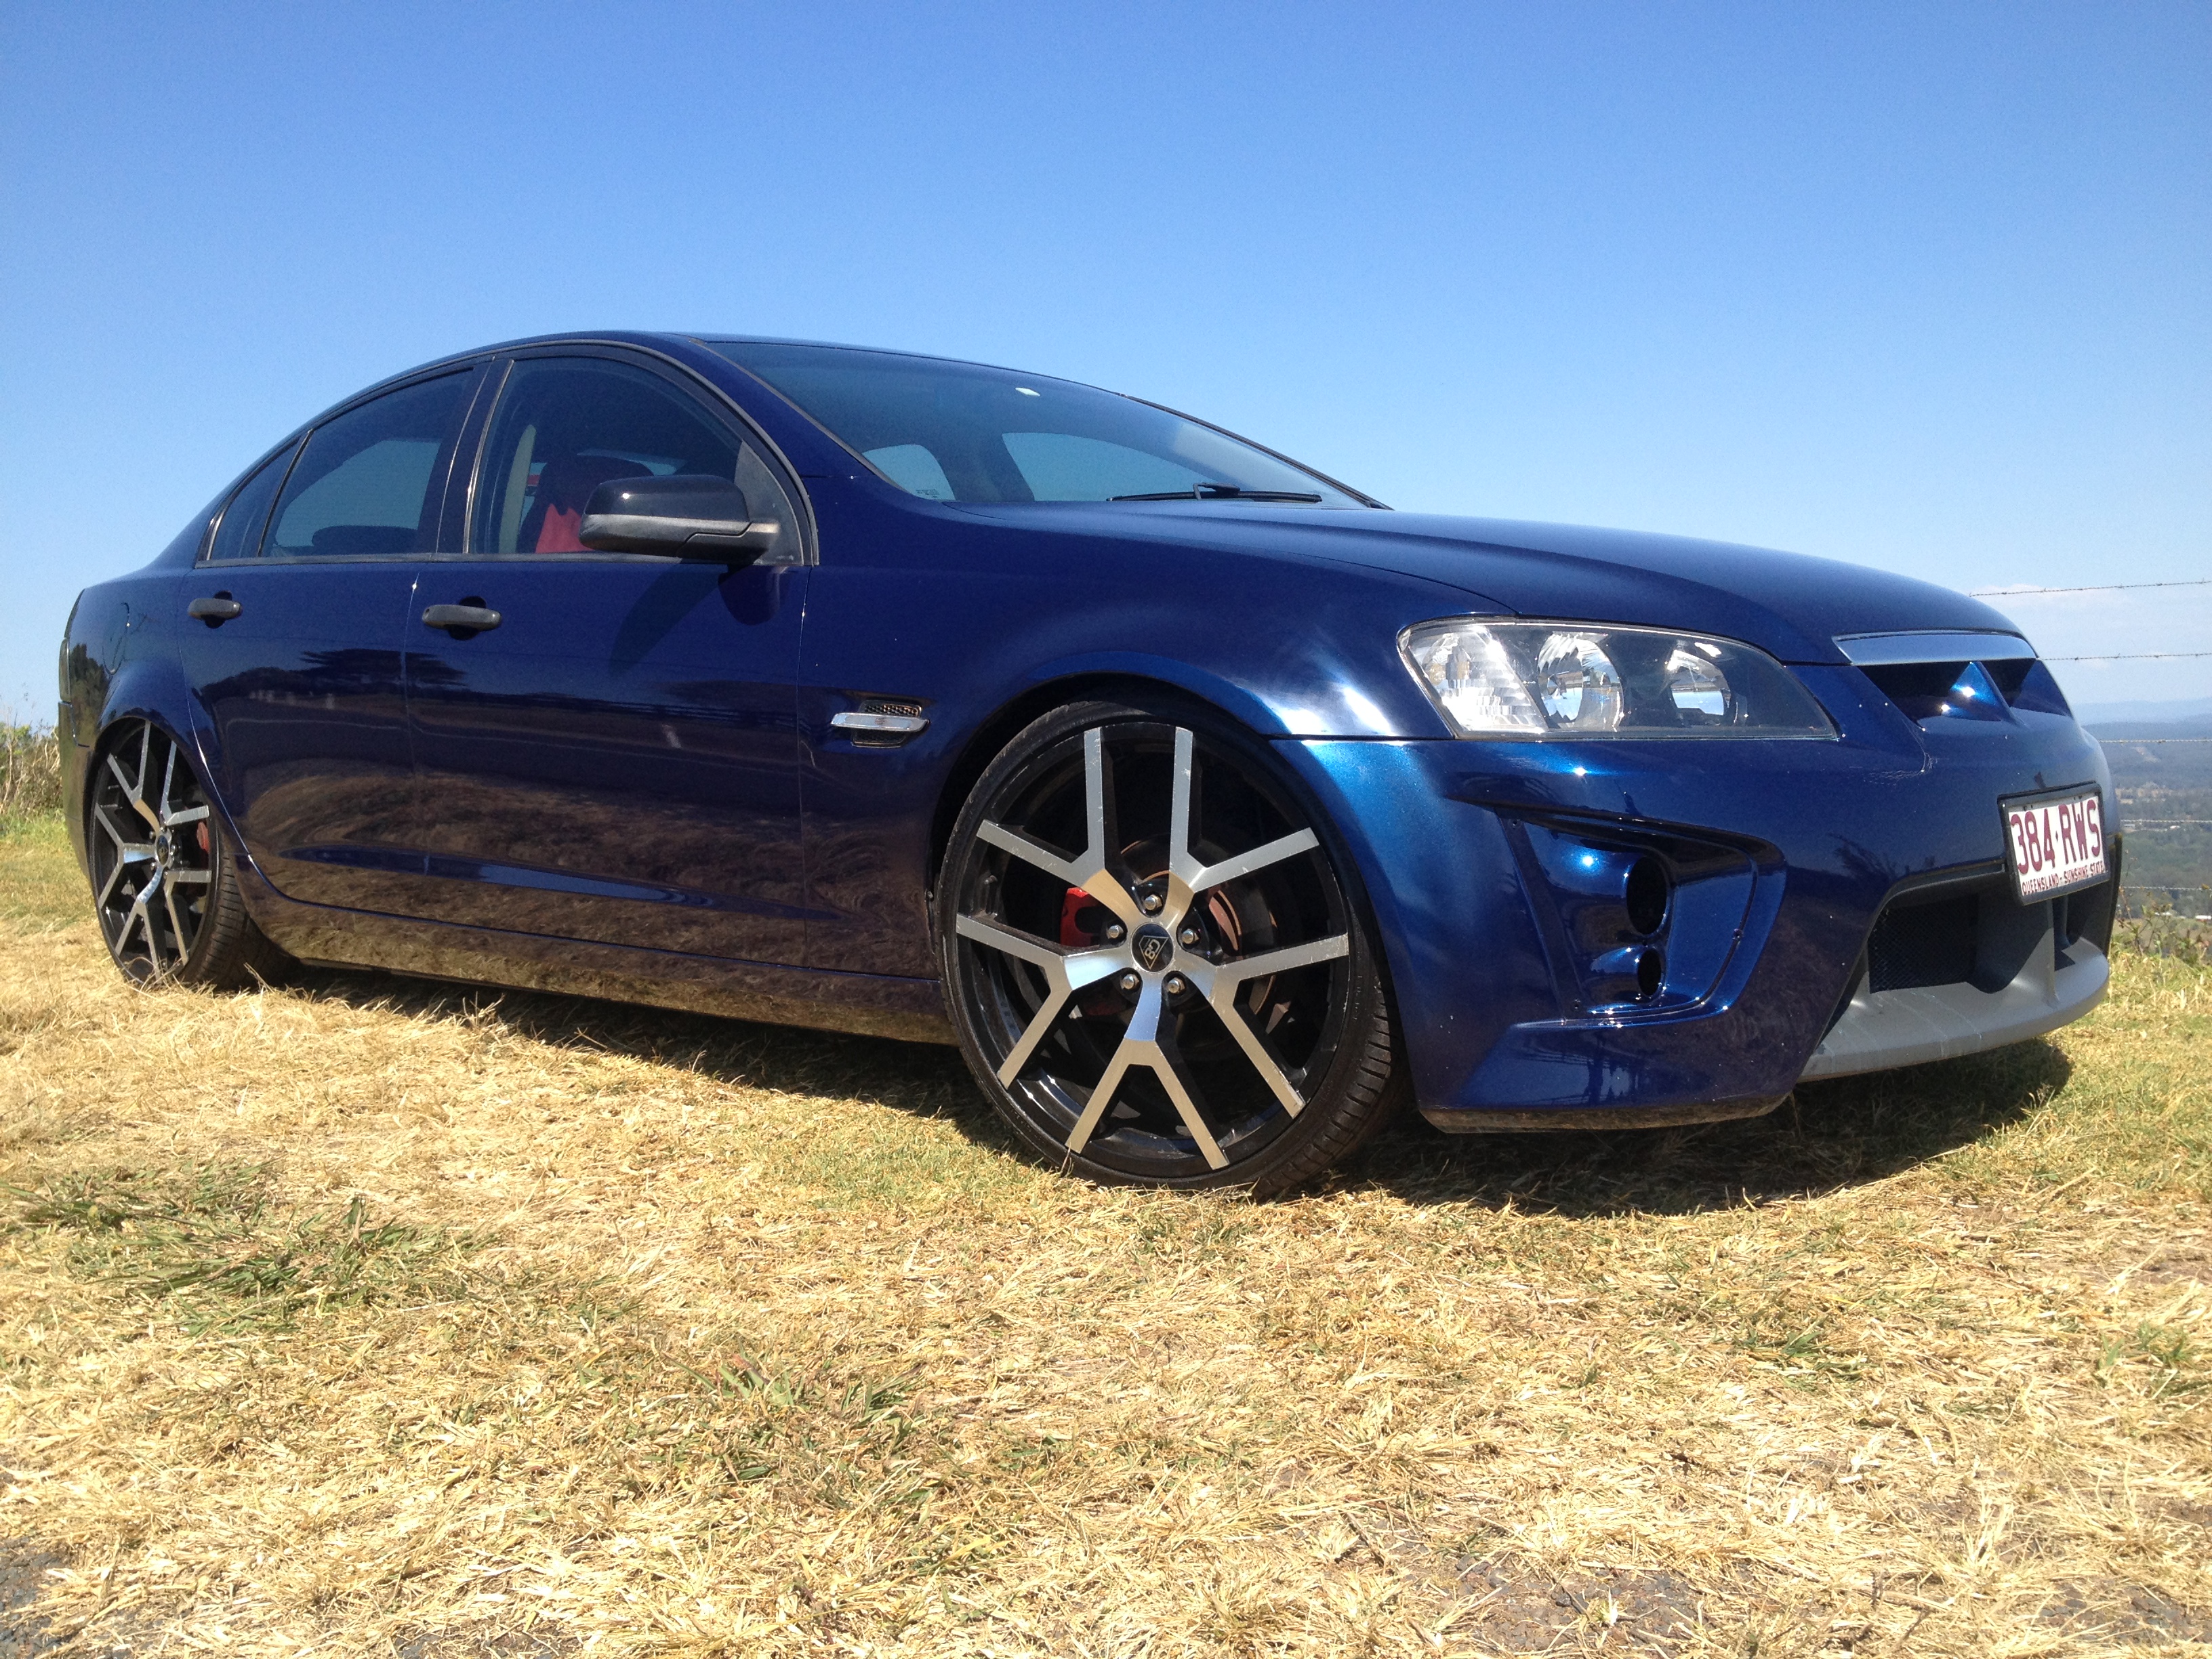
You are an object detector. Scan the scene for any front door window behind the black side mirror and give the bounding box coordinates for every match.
[469,359,801,564]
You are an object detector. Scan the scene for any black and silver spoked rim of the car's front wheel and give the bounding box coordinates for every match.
[956,721,1351,1181]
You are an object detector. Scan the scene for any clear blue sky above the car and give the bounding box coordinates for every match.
[0,0,2212,714]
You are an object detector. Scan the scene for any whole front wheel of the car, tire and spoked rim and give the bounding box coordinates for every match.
[936,701,1405,1192]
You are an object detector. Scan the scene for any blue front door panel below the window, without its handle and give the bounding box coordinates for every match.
[396,555,812,962]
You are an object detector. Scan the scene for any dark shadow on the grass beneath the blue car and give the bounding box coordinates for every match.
[292,969,2072,1216]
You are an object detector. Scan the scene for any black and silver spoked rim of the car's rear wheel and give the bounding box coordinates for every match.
[89,721,215,984]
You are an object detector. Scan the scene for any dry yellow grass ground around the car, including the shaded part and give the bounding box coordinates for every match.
[0,827,2212,1659]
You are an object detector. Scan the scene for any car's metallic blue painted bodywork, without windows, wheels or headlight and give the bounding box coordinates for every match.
[62,334,2112,1122]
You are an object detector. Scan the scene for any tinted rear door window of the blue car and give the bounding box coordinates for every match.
[266,371,473,558]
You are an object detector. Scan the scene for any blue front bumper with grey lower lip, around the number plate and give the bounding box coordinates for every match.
[1281,668,2114,1130]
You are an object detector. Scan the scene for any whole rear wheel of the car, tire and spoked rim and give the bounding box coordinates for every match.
[84,719,290,989]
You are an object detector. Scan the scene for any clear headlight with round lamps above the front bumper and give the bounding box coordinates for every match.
[1398,617,1836,739]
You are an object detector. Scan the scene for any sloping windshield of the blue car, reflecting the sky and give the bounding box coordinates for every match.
[703,341,1367,506]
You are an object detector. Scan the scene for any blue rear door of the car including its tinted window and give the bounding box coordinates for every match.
[182,367,480,909]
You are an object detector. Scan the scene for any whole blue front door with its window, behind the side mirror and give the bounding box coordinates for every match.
[405,356,807,962]
